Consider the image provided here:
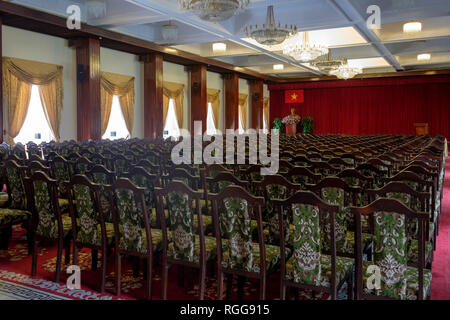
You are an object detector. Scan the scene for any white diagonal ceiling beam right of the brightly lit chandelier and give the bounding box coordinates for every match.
[328,0,405,71]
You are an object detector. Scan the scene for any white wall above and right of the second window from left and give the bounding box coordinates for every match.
[100,48,144,138]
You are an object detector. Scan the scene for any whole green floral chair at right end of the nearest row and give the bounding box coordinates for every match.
[351,198,432,300]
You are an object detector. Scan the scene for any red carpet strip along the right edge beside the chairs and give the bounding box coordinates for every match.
[431,157,450,300]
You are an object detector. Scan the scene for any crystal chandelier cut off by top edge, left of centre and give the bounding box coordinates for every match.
[178,0,250,22]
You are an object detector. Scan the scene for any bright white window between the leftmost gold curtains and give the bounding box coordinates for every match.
[14,86,55,144]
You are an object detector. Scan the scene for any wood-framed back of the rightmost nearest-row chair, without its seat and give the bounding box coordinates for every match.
[351,198,428,300]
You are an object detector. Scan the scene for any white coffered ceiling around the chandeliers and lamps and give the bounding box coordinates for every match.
[10,0,450,78]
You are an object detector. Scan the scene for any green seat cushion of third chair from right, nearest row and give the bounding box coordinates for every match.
[222,239,291,273]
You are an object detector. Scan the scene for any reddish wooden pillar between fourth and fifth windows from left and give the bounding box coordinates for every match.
[224,73,239,130]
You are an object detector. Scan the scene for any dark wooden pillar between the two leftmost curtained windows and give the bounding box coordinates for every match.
[69,38,102,141]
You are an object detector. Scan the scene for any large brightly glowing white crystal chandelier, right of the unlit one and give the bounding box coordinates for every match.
[283,32,328,62]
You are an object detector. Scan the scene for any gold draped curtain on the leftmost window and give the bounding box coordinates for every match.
[3,57,64,145]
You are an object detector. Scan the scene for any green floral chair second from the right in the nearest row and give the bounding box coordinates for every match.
[273,191,354,300]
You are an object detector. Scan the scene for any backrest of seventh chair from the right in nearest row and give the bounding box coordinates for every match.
[25,171,64,239]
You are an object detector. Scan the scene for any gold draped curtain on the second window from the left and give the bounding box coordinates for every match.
[101,72,135,137]
